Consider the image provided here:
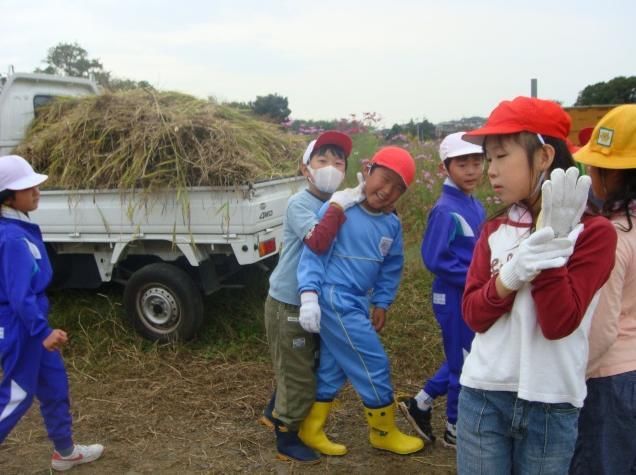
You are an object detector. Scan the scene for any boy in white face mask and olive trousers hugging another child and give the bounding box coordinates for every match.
[265,131,364,463]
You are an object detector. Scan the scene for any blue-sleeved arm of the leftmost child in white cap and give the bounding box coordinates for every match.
[0,238,53,341]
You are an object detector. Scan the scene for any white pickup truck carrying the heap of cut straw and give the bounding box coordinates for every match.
[0,69,305,341]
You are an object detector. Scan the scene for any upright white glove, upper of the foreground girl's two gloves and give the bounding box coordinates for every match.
[540,167,592,238]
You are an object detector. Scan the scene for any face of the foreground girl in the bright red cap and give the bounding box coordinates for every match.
[484,137,541,205]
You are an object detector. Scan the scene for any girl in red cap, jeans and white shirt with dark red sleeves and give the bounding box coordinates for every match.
[457,97,616,475]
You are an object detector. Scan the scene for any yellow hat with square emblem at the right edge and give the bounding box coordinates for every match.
[574,104,636,169]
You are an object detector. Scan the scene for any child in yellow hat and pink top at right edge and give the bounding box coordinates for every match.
[570,105,636,474]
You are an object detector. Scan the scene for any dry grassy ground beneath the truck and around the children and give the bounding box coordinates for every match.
[0,134,500,474]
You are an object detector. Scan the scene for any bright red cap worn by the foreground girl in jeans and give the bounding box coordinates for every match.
[463,96,572,145]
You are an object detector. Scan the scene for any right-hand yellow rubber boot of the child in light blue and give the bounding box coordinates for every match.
[364,403,424,455]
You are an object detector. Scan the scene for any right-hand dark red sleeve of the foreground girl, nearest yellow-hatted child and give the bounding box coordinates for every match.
[532,216,617,340]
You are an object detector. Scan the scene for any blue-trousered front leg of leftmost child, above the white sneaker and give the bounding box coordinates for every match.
[35,351,73,455]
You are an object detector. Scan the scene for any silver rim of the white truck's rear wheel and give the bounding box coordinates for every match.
[137,284,181,333]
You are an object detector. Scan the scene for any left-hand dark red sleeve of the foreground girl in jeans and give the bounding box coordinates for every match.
[462,221,516,333]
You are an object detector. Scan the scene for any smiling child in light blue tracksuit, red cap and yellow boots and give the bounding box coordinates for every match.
[298,147,424,454]
